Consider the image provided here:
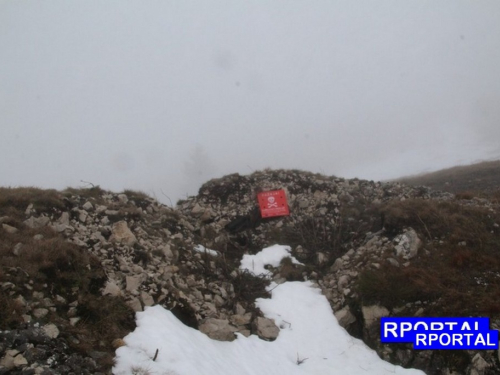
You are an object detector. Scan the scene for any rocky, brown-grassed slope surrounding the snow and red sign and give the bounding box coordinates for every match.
[0,170,500,374]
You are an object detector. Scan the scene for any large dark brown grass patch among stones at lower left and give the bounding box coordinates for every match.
[0,227,135,371]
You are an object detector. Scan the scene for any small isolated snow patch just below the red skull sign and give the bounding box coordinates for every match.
[240,245,301,276]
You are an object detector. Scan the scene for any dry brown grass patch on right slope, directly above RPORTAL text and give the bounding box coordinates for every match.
[358,200,500,317]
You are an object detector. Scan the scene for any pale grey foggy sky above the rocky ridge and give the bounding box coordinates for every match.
[0,0,500,203]
